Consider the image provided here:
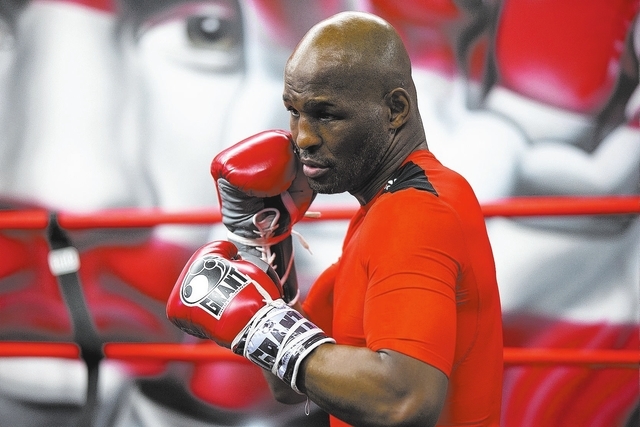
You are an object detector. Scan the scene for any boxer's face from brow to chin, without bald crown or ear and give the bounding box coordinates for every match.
[283,61,390,194]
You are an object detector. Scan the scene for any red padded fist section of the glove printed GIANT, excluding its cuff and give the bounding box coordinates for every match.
[167,241,282,348]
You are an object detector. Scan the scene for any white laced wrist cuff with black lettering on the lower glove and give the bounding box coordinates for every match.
[231,299,335,394]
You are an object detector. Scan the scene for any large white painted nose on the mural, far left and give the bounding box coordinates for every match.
[0,2,148,210]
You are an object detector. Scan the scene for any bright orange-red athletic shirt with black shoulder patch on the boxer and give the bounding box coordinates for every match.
[303,150,503,427]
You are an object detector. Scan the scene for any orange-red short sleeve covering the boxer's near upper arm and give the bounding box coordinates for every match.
[361,189,464,375]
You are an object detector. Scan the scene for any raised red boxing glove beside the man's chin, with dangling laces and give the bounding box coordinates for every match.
[211,130,315,304]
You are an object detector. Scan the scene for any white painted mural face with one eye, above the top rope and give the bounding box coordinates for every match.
[0,0,247,227]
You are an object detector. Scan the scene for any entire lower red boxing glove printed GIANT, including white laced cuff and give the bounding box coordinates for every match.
[167,241,335,393]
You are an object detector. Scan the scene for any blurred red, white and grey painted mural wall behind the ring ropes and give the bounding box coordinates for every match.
[0,0,640,427]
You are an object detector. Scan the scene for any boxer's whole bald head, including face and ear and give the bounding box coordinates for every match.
[282,12,428,205]
